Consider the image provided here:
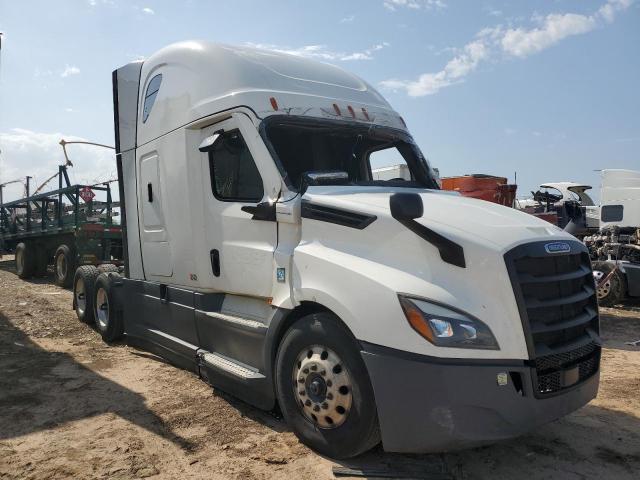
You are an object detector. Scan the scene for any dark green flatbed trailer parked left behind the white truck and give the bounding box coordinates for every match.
[0,166,123,287]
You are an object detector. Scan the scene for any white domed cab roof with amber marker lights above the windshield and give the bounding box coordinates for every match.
[138,41,406,144]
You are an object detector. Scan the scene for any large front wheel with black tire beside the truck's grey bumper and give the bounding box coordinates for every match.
[276,312,380,459]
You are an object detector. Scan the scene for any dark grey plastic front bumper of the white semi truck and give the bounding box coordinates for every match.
[362,343,599,453]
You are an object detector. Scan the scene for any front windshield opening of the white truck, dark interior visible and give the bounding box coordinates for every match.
[262,116,439,190]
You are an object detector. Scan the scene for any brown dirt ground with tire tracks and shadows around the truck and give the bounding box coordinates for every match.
[0,256,640,480]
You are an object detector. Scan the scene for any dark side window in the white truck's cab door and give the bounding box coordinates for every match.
[209,130,264,202]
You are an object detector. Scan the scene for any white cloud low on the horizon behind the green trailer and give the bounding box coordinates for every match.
[0,128,117,201]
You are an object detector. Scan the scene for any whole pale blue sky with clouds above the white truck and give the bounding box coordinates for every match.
[0,0,640,202]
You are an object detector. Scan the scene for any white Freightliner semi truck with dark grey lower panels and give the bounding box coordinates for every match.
[74,42,600,458]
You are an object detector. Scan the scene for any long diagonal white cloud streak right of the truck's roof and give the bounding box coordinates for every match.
[380,0,634,97]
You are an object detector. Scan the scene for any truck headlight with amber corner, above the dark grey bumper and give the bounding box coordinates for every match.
[398,295,500,350]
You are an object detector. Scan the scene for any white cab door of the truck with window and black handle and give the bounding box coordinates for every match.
[201,114,280,298]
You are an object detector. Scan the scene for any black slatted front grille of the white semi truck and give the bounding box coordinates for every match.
[505,242,600,396]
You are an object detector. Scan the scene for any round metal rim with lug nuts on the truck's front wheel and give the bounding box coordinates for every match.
[293,345,353,429]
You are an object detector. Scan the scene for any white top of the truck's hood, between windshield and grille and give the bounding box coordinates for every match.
[303,186,573,251]
